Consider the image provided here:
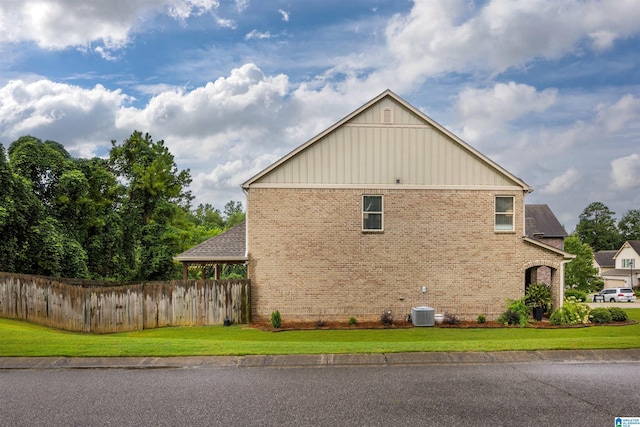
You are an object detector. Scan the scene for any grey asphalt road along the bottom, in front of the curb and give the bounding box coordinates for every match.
[0,359,640,427]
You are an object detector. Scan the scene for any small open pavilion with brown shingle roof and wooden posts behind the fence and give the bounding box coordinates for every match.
[173,221,248,280]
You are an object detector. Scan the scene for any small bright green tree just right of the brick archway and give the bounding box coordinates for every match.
[564,234,603,292]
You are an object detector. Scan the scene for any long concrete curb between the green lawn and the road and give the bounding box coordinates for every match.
[0,348,640,370]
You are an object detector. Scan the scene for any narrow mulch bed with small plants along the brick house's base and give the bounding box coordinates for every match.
[249,318,638,332]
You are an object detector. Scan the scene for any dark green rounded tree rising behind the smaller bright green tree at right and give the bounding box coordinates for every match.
[576,202,623,252]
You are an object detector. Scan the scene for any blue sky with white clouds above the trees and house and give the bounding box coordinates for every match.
[0,0,640,231]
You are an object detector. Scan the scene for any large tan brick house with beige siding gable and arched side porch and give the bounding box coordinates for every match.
[235,91,574,322]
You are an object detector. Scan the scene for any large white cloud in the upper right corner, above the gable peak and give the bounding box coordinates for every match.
[386,0,640,80]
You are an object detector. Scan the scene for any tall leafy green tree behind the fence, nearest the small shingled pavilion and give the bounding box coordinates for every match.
[109,131,192,280]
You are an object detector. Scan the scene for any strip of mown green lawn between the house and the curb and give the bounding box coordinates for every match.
[0,309,640,357]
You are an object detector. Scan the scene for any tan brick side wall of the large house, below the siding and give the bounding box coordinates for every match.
[247,187,561,321]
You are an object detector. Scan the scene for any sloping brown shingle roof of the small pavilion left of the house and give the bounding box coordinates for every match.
[173,221,247,262]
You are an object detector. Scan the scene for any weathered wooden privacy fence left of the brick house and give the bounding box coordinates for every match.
[0,273,251,333]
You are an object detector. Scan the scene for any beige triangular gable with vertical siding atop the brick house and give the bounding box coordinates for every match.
[242,90,533,192]
